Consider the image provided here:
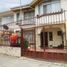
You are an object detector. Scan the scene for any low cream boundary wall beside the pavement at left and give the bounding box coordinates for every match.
[0,46,21,57]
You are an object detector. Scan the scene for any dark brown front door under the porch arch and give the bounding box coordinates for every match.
[41,32,48,48]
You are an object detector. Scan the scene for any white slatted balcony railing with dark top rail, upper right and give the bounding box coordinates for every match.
[36,11,67,25]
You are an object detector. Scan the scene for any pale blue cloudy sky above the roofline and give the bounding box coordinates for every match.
[0,0,32,12]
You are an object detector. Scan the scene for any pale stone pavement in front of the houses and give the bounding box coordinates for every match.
[0,54,67,67]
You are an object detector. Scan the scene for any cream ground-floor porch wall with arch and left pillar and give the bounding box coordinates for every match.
[36,24,66,51]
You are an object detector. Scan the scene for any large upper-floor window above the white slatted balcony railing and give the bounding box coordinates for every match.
[43,0,61,14]
